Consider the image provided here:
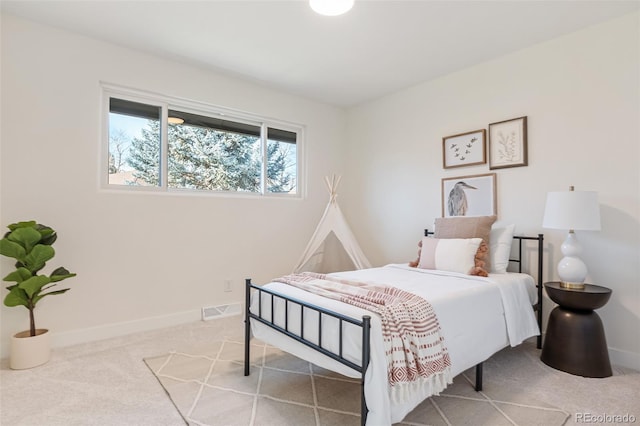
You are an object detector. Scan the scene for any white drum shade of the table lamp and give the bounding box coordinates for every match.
[542,191,600,231]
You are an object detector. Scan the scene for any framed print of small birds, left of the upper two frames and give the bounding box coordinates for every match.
[442,129,487,169]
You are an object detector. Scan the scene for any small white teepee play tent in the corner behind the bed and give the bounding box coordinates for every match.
[294,175,371,273]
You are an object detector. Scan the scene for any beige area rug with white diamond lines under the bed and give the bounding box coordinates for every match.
[145,339,569,426]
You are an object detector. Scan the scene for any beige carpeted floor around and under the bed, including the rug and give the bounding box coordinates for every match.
[0,315,640,426]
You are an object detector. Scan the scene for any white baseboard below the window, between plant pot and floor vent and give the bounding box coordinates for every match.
[51,309,201,348]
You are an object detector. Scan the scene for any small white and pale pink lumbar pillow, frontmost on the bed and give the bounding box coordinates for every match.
[418,237,482,274]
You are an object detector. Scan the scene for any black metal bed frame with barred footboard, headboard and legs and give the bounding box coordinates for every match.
[244,233,544,425]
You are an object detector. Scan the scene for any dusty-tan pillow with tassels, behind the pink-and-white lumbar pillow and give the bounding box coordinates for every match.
[433,216,496,276]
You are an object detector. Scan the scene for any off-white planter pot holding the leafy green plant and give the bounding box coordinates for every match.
[9,328,51,370]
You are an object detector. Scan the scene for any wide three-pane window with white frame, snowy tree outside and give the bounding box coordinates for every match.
[105,86,302,195]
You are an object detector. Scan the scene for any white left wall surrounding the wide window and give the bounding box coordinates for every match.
[0,15,345,355]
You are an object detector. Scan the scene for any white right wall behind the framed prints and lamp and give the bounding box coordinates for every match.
[341,13,640,369]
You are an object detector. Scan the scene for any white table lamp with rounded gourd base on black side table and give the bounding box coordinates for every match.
[542,186,600,290]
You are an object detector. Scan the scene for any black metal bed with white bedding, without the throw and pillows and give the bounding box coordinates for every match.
[244,225,543,425]
